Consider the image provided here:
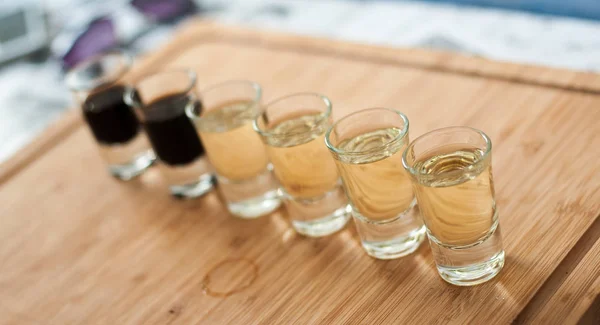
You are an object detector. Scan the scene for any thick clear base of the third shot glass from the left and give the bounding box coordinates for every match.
[227,190,281,219]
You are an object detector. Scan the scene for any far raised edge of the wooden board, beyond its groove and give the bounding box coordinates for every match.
[133,20,600,95]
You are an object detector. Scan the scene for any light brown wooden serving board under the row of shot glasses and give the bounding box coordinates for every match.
[0,22,600,324]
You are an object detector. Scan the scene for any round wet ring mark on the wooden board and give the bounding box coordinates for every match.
[201,258,258,297]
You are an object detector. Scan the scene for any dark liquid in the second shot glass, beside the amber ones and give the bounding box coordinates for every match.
[144,95,204,165]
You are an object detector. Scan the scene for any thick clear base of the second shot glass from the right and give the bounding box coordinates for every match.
[362,226,425,260]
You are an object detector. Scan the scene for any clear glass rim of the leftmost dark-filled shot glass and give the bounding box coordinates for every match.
[65,50,133,91]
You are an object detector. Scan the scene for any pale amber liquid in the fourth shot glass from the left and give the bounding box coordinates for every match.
[267,114,339,198]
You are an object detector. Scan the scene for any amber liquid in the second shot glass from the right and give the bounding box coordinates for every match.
[336,128,414,221]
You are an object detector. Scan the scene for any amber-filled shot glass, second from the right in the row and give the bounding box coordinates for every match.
[325,108,425,259]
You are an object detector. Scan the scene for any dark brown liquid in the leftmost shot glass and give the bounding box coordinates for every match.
[82,86,140,144]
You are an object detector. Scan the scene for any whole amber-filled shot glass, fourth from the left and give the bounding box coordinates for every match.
[254,93,350,237]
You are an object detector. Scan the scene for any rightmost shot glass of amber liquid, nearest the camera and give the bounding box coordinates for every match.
[402,127,504,286]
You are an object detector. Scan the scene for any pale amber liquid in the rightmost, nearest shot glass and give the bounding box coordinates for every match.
[414,148,496,246]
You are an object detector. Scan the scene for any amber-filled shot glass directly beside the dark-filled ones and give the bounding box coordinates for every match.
[188,81,281,219]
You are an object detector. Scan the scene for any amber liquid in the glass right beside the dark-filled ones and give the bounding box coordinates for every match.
[198,100,268,180]
